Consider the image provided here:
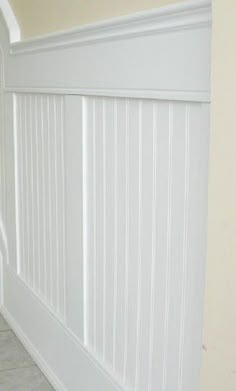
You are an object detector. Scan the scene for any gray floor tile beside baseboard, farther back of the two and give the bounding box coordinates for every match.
[0,331,34,370]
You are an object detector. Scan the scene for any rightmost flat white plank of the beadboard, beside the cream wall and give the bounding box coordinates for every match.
[180,104,209,391]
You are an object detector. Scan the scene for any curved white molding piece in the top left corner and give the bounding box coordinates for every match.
[0,0,21,43]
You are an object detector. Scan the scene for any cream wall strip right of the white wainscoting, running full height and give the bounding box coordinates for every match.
[202,0,236,391]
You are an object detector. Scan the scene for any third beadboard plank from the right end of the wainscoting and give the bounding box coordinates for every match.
[149,102,171,390]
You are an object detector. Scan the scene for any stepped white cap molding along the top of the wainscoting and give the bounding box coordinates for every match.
[11,0,211,54]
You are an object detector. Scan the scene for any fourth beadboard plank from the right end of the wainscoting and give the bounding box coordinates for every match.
[136,102,156,391]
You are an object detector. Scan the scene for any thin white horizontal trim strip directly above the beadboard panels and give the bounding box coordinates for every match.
[4,87,210,103]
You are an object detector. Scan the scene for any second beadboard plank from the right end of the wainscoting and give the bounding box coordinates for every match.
[164,103,189,390]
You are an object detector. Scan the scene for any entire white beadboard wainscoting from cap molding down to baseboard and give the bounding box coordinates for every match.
[0,0,211,391]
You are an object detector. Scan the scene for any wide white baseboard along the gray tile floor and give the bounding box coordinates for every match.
[0,264,121,391]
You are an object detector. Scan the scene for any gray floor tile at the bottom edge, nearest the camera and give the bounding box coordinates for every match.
[0,366,53,391]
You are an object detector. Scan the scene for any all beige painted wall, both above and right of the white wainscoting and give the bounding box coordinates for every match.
[8,0,236,391]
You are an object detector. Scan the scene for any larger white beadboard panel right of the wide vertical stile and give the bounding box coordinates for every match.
[86,98,207,390]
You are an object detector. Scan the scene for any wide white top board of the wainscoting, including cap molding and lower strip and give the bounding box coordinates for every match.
[5,0,211,102]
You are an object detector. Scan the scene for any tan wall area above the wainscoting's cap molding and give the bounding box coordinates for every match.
[10,0,178,39]
